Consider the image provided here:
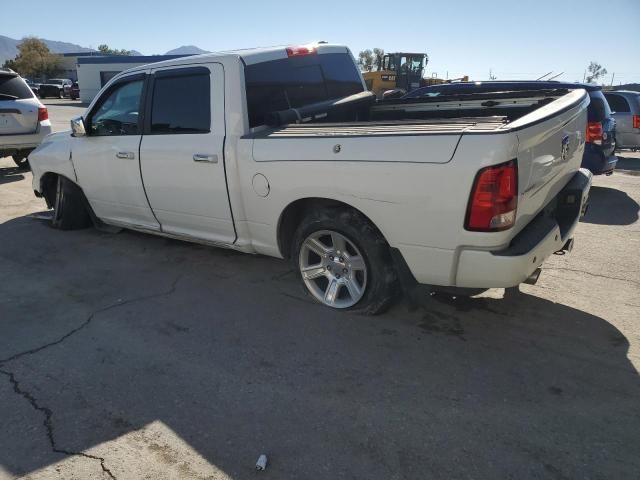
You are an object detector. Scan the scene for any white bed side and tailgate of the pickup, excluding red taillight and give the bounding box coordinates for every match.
[240,86,589,285]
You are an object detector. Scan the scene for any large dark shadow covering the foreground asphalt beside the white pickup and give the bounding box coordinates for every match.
[0,216,640,480]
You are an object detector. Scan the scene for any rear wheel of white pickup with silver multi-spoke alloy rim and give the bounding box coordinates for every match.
[292,208,398,315]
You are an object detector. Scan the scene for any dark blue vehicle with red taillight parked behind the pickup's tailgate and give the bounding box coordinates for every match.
[403,81,618,175]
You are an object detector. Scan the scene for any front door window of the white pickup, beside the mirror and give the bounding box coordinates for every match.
[89,80,144,136]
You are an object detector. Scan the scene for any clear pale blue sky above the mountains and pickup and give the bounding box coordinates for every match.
[5,0,640,84]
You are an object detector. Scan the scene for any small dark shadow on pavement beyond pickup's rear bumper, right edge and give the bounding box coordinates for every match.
[582,186,640,225]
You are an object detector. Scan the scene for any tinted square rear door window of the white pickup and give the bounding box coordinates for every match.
[151,71,211,135]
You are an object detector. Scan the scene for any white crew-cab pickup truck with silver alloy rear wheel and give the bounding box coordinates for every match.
[30,44,591,313]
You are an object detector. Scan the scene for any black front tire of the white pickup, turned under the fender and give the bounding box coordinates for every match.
[51,176,92,230]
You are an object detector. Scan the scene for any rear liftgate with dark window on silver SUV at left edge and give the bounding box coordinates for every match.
[0,72,39,135]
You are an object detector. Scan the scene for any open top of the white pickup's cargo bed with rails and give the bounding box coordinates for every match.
[244,89,579,139]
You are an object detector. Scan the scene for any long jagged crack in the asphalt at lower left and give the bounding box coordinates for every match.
[0,277,180,480]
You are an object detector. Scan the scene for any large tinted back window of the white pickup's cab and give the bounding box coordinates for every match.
[245,53,364,127]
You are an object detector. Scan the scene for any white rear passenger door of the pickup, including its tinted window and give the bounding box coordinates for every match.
[140,63,236,244]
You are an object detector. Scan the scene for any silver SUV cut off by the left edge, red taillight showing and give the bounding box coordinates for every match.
[0,69,51,167]
